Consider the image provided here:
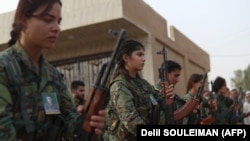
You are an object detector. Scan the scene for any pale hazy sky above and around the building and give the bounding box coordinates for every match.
[0,0,250,88]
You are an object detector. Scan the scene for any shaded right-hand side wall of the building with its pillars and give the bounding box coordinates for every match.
[120,0,210,94]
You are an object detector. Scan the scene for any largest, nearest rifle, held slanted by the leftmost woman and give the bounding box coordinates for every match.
[82,29,126,133]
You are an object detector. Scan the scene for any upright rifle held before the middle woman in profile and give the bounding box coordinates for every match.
[157,46,174,124]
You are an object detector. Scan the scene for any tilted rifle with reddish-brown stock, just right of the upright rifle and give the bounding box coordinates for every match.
[174,73,207,121]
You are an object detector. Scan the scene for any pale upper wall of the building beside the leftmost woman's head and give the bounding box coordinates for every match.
[62,0,122,30]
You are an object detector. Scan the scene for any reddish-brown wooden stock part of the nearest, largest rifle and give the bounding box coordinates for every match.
[82,89,108,133]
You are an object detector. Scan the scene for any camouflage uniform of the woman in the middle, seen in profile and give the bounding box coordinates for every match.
[105,75,162,141]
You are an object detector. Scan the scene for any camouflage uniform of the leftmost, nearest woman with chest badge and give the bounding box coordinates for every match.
[0,43,80,141]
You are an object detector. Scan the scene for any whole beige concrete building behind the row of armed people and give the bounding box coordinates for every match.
[0,0,210,95]
